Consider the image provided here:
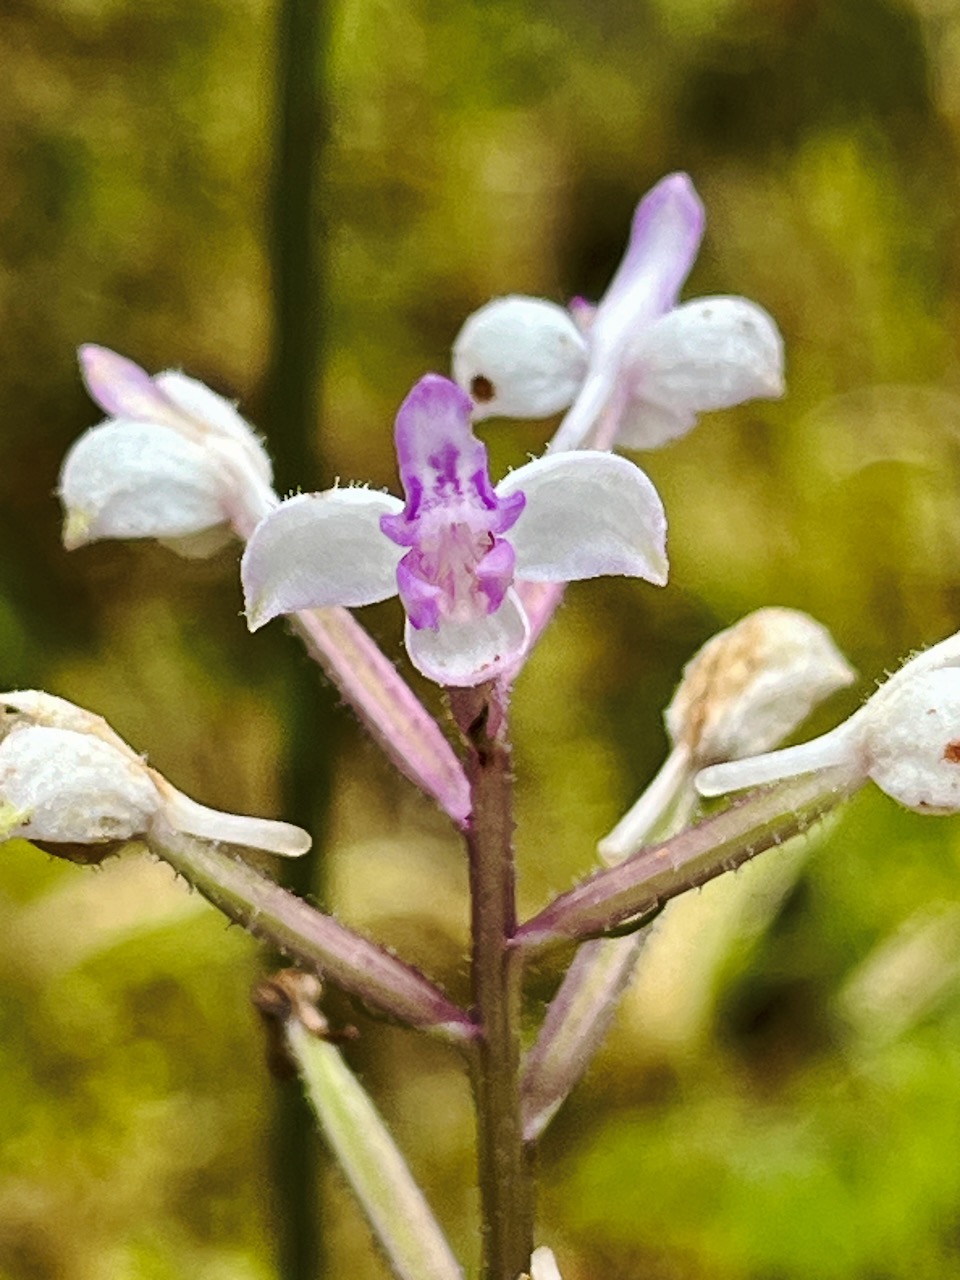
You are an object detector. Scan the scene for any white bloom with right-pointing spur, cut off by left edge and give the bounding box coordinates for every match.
[0,690,310,856]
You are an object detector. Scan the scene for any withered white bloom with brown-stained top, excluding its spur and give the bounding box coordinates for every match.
[664,608,854,764]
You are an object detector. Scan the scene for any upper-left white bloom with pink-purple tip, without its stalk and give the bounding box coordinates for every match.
[60,346,276,556]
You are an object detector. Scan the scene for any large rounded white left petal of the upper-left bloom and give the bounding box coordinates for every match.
[60,419,225,549]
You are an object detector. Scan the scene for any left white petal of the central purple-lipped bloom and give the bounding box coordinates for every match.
[241,489,403,631]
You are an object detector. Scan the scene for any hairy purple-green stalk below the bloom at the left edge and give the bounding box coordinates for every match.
[147,817,476,1043]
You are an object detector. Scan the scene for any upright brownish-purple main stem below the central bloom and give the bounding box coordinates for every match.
[451,685,532,1280]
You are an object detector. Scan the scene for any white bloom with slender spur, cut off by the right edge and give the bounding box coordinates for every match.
[696,632,960,813]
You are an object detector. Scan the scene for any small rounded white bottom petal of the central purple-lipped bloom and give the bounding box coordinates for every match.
[406,591,530,687]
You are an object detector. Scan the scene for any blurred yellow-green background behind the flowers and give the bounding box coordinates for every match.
[0,0,960,1280]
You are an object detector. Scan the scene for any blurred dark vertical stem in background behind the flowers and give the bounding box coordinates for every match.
[266,0,335,1280]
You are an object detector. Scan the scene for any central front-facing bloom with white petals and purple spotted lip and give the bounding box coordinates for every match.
[241,374,667,685]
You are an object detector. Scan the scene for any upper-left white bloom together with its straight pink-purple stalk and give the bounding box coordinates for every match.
[60,346,468,826]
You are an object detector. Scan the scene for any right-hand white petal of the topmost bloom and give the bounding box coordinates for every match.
[626,297,783,447]
